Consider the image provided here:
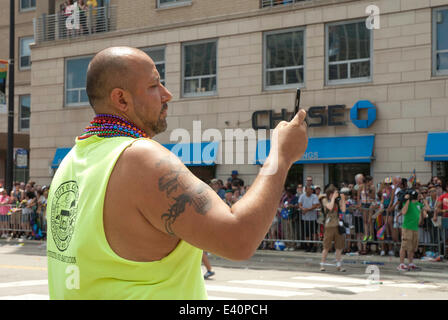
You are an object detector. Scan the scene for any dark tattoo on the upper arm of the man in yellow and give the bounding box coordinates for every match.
[157,159,211,235]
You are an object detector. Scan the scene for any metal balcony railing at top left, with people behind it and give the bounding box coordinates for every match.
[34,6,117,44]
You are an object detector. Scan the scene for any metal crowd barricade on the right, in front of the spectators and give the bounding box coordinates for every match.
[260,204,448,257]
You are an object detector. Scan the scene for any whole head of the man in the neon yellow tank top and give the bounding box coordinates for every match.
[86,47,173,137]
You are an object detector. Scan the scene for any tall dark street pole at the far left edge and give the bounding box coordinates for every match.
[5,0,15,194]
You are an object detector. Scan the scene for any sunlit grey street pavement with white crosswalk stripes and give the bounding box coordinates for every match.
[0,241,448,300]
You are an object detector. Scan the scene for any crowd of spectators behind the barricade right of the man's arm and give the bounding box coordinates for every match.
[263,174,448,258]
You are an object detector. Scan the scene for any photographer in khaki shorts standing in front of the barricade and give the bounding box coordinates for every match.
[320,185,346,272]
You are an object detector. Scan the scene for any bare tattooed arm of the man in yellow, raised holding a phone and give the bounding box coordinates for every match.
[123,110,308,260]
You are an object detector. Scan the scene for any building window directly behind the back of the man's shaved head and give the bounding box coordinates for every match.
[65,57,92,106]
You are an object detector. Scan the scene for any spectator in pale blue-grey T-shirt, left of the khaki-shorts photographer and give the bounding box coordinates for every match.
[298,186,320,252]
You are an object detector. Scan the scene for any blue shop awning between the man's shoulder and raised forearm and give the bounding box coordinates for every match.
[163,142,219,166]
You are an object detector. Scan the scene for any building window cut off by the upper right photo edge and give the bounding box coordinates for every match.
[432,7,448,75]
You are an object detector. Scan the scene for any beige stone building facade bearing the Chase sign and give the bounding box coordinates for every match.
[21,0,448,189]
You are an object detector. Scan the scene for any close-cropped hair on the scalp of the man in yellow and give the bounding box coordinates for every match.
[86,47,153,111]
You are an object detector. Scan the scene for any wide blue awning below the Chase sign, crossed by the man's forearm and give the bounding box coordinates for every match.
[255,135,375,164]
